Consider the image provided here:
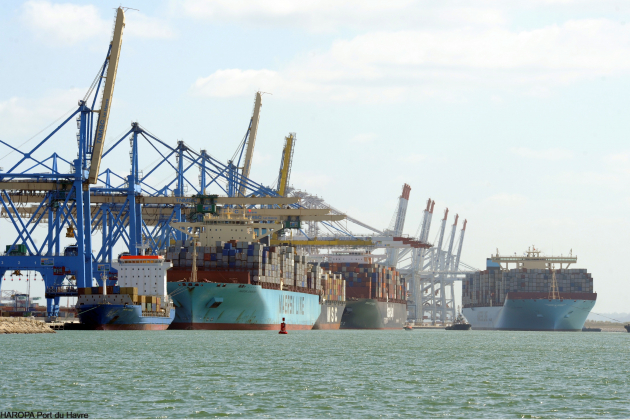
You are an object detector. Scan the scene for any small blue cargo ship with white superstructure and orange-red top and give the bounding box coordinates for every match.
[76,255,175,330]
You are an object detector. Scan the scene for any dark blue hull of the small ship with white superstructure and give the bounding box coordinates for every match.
[77,304,175,330]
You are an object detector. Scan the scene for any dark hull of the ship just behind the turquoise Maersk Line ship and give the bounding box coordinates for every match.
[341,299,407,330]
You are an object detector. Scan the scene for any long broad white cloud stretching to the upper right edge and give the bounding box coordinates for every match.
[192,19,630,102]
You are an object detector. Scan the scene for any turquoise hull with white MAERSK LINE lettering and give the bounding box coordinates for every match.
[167,282,321,330]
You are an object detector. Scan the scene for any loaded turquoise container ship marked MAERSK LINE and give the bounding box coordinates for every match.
[166,212,343,330]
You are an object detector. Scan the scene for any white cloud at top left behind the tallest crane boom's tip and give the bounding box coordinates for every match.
[22,0,175,45]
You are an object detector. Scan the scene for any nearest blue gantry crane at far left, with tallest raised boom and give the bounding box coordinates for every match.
[0,8,125,316]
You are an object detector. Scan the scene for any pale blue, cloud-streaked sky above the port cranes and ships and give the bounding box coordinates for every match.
[0,0,630,312]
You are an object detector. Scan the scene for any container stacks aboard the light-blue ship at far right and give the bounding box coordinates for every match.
[462,268,593,308]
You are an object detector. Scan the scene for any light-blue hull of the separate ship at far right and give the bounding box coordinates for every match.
[463,292,597,331]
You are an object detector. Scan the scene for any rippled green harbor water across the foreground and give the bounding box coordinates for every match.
[0,330,630,418]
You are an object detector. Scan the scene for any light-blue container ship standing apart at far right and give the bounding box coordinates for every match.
[462,247,597,331]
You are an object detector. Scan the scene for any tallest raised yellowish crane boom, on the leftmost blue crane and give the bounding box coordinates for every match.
[88,7,125,184]
